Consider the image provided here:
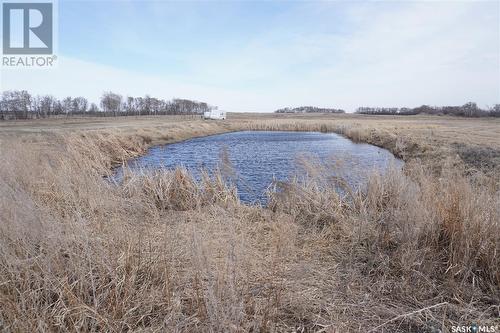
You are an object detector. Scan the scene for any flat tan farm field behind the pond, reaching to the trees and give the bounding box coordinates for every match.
[0,113,500,174]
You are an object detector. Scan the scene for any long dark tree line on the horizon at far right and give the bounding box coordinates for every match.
[356,102,500,117]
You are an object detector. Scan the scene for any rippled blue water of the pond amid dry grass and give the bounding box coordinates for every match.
[115,131,402,204]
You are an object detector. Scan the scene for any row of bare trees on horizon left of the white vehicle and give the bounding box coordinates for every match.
[0,90,214,120]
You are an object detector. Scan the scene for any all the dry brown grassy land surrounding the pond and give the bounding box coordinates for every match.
[0,114,500,332]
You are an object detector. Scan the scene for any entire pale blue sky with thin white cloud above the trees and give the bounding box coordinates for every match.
[0,0,500,112]
